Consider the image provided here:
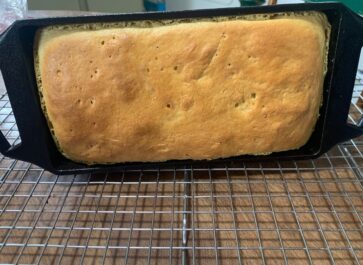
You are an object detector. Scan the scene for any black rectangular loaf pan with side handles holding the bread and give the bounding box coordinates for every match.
[0,3,363,174]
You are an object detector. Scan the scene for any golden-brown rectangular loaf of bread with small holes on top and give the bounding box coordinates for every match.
[34,12,330,164]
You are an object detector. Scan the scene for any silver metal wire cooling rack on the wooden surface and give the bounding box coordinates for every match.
[0,75,363,265]
